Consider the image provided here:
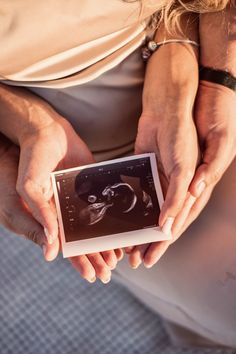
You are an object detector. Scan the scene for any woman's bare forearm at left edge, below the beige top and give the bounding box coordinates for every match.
[0,83,61,145]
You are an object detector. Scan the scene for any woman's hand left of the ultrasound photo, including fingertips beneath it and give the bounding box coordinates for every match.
[17,113,122,283]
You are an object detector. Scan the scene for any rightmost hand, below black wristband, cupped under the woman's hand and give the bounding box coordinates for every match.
[127,82,236,268]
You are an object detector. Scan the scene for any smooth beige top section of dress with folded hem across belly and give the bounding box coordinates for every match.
[0,0,161,88]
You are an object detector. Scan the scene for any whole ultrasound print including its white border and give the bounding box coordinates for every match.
[52,153,170,257]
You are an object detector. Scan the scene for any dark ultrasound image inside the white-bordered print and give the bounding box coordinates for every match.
[54,155,160,243]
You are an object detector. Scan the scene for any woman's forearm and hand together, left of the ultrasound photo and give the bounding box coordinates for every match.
[0,84,123,282]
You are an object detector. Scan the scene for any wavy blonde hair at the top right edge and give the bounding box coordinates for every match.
[123,0,236,33]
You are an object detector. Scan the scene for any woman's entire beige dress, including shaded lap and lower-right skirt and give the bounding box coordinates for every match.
[0,0,236,347]
